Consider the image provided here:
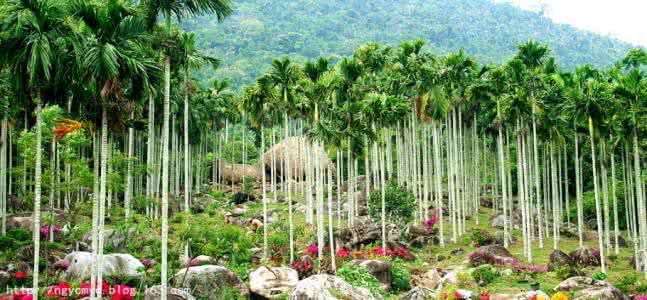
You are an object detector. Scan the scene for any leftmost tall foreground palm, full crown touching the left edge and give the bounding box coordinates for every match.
[0,0,66,299]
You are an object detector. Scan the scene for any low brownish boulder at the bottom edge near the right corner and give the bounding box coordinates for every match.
[555,276,629,300]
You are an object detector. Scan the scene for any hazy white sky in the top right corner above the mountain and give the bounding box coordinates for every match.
[495,0,647,46]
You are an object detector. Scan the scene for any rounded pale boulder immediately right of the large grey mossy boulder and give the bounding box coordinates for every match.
[249,267,299,299]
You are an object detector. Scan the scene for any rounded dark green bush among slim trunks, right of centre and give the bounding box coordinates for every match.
[368,181,416,224]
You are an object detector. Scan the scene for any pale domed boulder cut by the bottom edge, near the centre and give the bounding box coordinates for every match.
[288,274,377,300]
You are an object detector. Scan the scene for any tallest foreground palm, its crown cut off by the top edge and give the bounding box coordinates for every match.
[141,0,232,300]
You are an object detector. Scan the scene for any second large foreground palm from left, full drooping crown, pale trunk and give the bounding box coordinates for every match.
[71,0,156,298]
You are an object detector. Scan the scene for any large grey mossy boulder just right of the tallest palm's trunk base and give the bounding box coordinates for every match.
[173,265,247,299]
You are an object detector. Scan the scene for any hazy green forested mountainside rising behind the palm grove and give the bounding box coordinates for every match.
[183,0,631,86]
